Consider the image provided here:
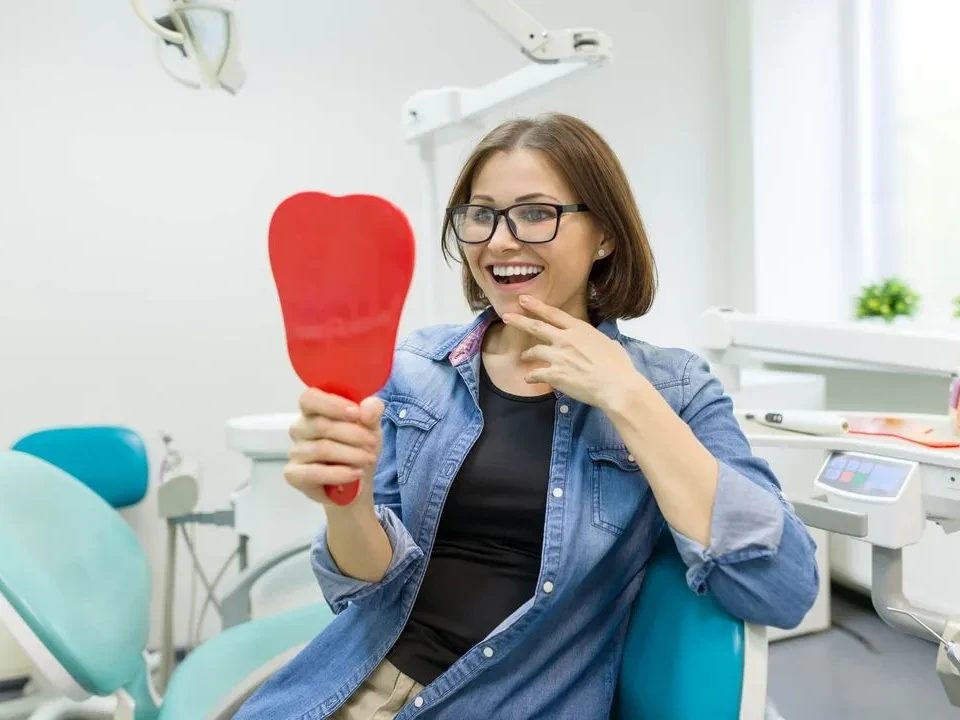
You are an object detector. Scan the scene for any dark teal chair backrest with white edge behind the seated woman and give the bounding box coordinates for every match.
[614,533,767,720]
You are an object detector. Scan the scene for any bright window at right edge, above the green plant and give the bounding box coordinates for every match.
[856,0,960,326]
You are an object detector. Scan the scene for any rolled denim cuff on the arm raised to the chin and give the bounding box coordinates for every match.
[670,462,784,595]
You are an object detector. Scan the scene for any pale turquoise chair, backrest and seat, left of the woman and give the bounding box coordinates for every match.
[0,451,332,720]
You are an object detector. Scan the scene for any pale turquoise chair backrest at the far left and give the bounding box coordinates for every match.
[0,451,150,695]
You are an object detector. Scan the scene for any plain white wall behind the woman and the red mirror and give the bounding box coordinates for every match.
[0,0,730,642]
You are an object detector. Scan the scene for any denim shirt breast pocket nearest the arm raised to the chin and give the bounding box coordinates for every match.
[588,447,649,535]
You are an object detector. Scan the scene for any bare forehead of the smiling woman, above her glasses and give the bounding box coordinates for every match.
[471,149,570,202]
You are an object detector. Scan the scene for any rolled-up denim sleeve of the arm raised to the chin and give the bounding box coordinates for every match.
[670,356,820,628]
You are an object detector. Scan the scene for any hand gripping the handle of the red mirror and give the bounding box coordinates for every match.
[283,388,383,512]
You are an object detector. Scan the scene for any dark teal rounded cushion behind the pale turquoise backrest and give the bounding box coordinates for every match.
[13,425,150,508]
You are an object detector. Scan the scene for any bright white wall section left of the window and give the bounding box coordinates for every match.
[726,0,859,320]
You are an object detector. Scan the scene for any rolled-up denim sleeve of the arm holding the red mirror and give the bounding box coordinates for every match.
[310,376,423,613]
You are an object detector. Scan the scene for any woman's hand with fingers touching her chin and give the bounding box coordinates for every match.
[501,295,643,410]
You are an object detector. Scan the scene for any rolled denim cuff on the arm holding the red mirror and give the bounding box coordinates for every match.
[310,506,423,613]
